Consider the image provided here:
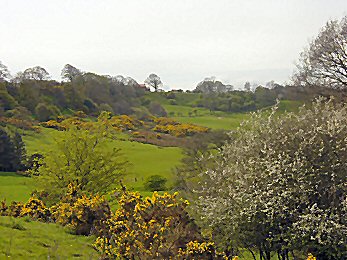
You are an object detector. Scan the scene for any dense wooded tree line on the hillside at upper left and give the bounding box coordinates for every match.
[0,63,145,121]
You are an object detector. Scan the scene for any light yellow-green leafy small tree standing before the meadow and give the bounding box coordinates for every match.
[33,117,126,201]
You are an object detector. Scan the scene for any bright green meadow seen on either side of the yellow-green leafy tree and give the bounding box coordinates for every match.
[23,128,183,191]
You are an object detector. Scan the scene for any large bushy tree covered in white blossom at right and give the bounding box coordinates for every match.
[197,99,347,259]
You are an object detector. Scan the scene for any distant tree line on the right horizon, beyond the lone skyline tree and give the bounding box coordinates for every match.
[193,78,343,112]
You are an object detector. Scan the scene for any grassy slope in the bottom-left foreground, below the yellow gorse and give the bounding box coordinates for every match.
[0,217,98,259]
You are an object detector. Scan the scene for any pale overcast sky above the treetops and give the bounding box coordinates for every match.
[0,0,347,89]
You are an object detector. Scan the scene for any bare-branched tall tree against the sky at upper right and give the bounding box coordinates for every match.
[293,16,347,89]
